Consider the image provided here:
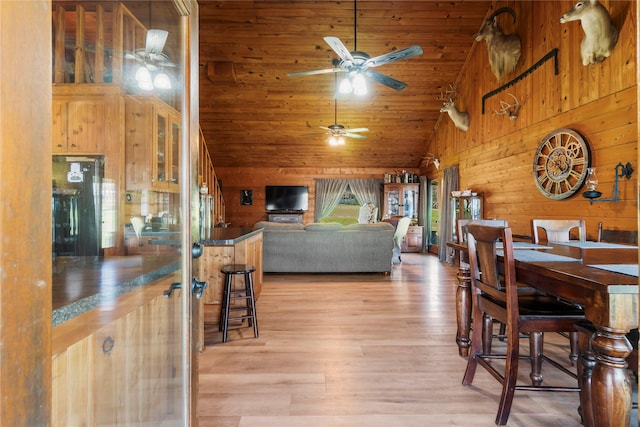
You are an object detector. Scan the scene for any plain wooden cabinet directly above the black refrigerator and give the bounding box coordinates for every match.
[51,96,106,154]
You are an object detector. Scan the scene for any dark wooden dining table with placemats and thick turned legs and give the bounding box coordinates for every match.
[447,241,638,427]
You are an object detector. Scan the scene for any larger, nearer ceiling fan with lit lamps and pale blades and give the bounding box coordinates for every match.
[287,0,422,94]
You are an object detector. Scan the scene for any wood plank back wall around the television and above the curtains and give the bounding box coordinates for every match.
[213,166,418,227]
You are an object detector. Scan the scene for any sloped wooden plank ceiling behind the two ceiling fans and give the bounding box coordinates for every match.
[199,0,492,170]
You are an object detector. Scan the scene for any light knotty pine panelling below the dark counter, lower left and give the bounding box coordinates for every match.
[51,276,181,426]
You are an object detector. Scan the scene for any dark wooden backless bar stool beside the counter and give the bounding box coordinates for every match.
[220,264,258,342]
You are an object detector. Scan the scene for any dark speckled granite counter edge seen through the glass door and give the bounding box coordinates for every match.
[52,262,180,326]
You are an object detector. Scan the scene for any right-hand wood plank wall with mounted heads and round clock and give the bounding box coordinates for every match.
[423,0,640,239]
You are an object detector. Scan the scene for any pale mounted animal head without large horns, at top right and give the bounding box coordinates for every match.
[560,0,618,66]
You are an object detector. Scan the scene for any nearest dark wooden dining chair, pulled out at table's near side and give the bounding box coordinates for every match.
[462,224,585,425]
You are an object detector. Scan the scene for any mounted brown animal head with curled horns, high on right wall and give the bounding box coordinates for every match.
[476,7,521,83]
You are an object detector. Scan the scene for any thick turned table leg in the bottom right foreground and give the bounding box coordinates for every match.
[581,326,632,427]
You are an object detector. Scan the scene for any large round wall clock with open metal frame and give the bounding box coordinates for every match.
[533,129,591,200]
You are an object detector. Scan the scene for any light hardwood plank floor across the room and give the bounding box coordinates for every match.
[198,254,637,427]
